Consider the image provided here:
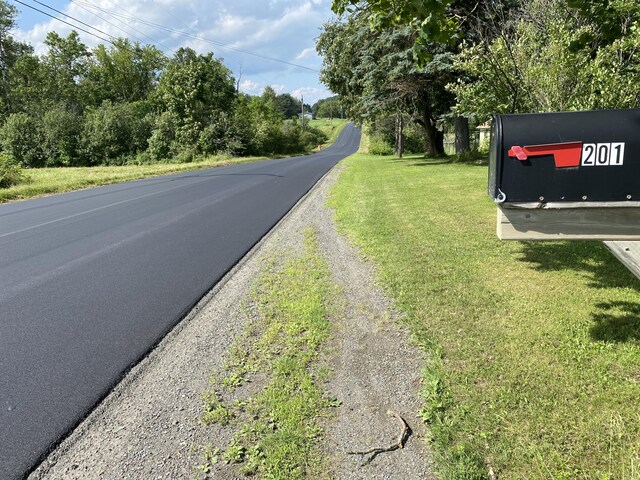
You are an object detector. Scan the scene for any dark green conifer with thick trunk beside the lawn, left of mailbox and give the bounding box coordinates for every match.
[317,12,453,155]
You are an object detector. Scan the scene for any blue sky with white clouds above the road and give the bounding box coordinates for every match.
[8,0,333,104]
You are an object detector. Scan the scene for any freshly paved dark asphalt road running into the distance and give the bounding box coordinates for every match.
[0,125,360,479]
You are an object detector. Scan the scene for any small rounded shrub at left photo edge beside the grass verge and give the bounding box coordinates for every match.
[0,113,46,167]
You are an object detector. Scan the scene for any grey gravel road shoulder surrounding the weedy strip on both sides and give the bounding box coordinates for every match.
[30,163,432,479]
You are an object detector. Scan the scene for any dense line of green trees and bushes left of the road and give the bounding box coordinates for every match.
[0,0,326,172]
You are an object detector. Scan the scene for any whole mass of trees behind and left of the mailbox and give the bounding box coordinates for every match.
[317,0,640,155]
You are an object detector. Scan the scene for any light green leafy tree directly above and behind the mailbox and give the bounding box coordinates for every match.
[450,0,640,121]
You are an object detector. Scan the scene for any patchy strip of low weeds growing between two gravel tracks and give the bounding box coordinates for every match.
[200,231,336,480]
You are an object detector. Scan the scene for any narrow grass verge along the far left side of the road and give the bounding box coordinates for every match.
[0,156,264,203]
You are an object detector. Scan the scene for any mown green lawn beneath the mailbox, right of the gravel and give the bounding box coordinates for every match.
[330,155,640,479]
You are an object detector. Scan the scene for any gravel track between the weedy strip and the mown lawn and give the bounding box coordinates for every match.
[305,166,435,479]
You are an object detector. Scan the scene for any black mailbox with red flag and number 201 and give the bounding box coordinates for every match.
[489,109,640,203]
